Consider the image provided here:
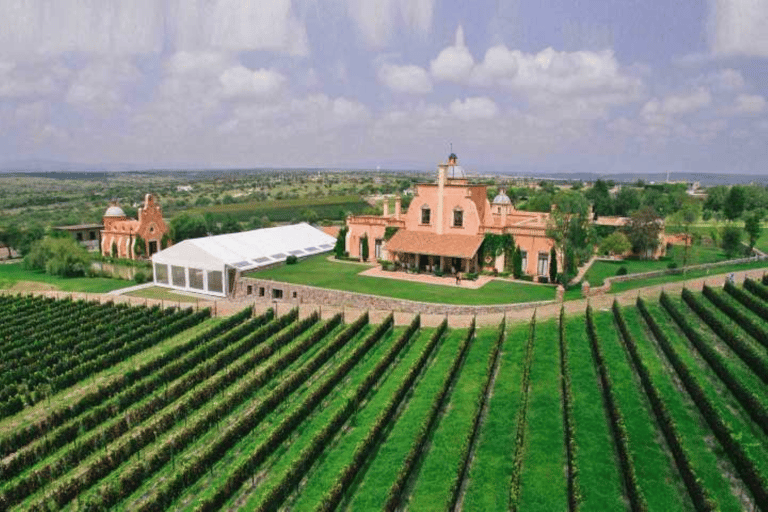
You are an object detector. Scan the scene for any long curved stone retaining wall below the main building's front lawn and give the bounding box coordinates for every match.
[235,277,554,316]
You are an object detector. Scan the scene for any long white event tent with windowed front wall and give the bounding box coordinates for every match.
[152,222,336,297]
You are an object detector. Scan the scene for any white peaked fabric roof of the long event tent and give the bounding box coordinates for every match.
[152,222,336,270]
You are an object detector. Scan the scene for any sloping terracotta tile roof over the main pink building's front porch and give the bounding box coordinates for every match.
[387,229,483,258]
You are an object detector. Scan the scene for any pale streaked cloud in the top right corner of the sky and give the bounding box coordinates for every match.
[709,0,768,57]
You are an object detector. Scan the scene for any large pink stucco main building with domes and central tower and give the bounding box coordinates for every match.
[346,154,562,276]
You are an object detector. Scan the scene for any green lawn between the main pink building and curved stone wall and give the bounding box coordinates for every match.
[250,254,555,305]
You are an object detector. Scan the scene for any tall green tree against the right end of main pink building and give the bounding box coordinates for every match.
[546,190,591,282]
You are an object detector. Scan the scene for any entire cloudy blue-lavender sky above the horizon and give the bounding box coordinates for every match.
[0,0,768,174]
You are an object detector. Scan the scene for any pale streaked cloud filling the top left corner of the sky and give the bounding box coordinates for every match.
[0,0,163,55]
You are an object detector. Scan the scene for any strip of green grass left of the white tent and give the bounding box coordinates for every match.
[0,263,129,293]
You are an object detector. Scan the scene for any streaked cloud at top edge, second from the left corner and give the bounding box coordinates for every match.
[168,0,309,55]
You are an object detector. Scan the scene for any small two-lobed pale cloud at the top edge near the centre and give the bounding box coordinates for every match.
[346,0,434,48]
